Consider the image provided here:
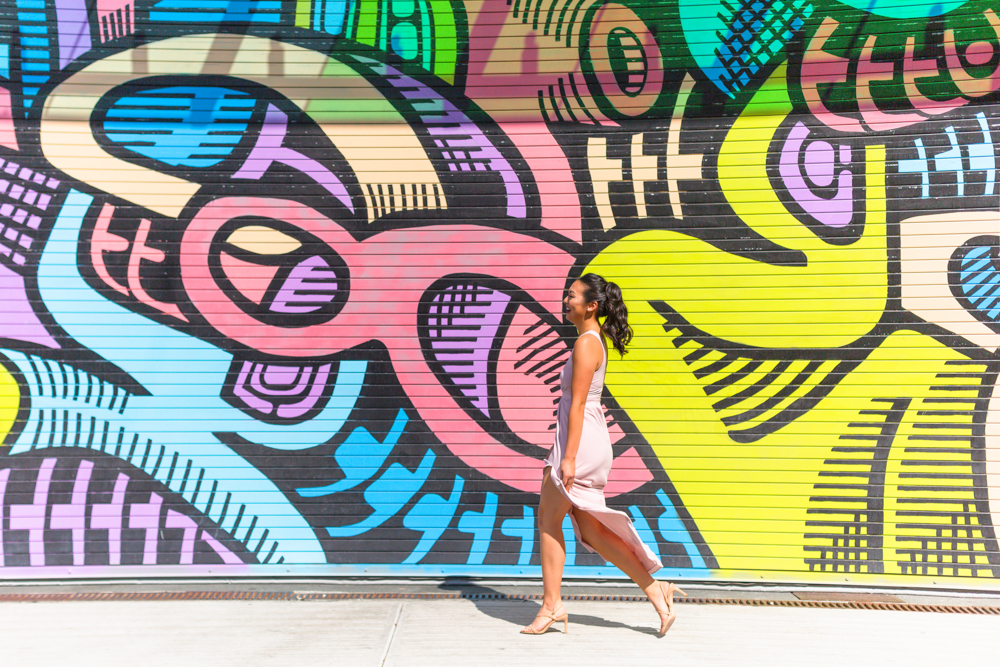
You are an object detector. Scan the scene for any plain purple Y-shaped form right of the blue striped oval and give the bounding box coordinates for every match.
[233,104,354,213]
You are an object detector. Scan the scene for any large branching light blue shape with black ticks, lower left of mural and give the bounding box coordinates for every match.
[7,190,376,564]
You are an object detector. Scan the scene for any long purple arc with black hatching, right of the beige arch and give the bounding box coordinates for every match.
[353,56,528,218]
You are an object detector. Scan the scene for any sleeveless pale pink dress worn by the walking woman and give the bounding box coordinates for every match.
[545,331,663,574]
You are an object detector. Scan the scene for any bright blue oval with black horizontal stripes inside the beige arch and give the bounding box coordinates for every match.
[104,86,257,168]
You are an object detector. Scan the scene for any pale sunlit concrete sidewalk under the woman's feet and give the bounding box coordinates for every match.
[0,586,1000,667]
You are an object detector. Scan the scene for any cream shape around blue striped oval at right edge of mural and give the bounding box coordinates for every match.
[899,211,1000,351]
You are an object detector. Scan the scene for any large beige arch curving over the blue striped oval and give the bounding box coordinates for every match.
[40,34,440,218]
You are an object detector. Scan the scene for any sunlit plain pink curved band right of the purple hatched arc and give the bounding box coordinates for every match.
[499,122,583,243]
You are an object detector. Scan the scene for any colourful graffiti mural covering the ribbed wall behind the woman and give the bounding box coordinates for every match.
[0,0,1000,589]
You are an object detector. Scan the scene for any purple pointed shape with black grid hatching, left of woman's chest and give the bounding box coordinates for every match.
[430,286,510,417]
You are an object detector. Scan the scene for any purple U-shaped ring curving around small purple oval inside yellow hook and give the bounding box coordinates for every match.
[778,122,854,228]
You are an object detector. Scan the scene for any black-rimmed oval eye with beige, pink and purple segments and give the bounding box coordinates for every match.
[209,217,350,328]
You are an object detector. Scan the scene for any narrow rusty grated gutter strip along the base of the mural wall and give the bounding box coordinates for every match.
[0,591,1000,616]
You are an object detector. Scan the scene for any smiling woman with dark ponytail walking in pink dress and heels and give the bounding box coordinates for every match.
[521,273,685,636]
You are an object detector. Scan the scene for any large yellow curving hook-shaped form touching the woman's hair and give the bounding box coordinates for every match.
[588,67,888,349]
